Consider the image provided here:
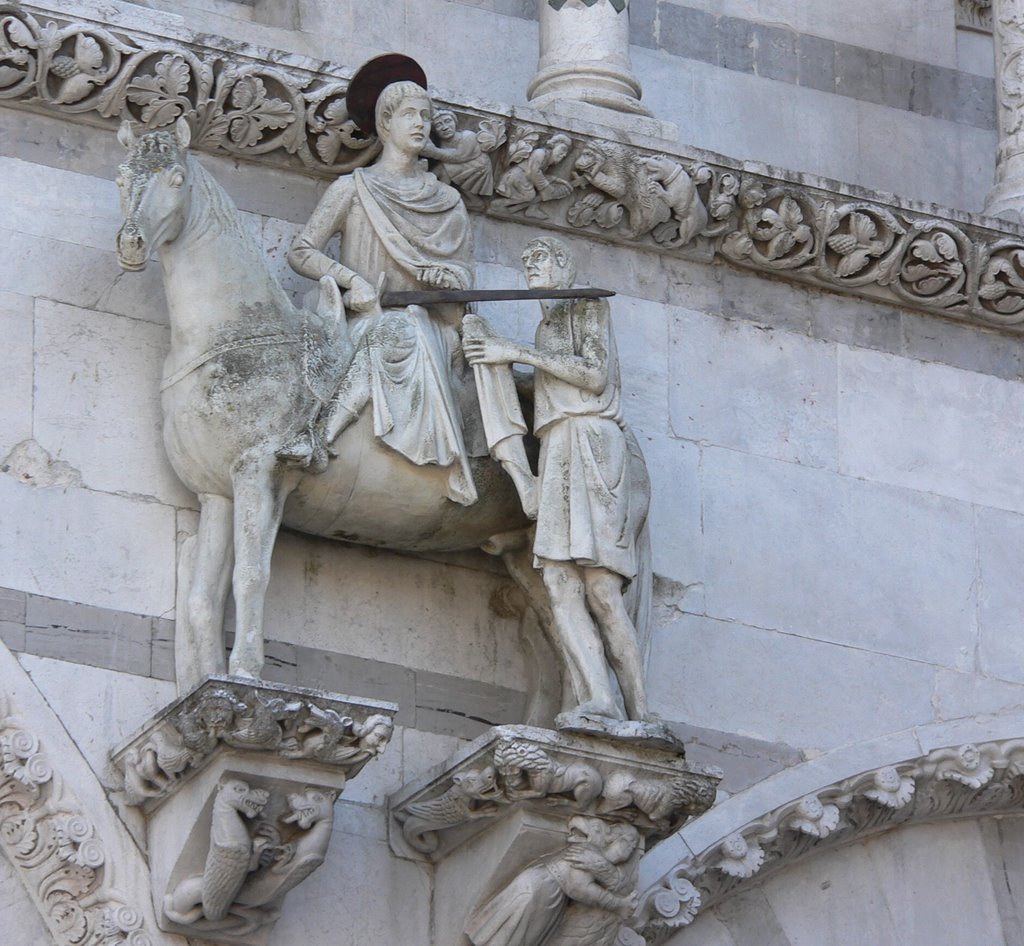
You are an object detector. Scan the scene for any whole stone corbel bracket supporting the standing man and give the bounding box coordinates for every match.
[388,726,719,946]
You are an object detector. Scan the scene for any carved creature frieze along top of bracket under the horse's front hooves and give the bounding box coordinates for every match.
[111,677,397,812]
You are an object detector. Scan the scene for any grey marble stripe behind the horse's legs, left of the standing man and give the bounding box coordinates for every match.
[0,588,525,739]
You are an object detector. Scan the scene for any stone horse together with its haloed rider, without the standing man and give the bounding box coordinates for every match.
[118,56,650,720]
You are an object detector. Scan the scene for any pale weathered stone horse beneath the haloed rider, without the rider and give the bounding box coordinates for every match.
[117,119,649,724]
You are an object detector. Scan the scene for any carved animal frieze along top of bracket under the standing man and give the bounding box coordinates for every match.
[391,726,720,861]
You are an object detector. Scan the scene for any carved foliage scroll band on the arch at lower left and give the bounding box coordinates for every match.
[0,697,153,946]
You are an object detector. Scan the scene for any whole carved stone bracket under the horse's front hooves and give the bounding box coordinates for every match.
[112,677,398,946]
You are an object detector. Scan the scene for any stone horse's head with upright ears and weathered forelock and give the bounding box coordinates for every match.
[117,118,191,272]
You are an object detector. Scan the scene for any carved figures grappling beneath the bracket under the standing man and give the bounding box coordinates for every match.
[466,816,640,946]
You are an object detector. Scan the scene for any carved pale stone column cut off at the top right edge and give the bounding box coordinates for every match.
[985,0,1024,222]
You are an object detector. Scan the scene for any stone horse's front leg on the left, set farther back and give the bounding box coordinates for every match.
[174,493,231,694]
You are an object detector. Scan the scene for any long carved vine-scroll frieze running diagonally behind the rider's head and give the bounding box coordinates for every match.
[6,3,1024,334]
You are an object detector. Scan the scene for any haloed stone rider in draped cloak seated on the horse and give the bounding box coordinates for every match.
[279,54,536,513]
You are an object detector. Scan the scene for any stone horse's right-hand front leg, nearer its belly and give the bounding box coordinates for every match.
[227,455,294,680]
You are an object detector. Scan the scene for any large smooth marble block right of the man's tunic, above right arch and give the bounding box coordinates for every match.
[703,448,977,668]
